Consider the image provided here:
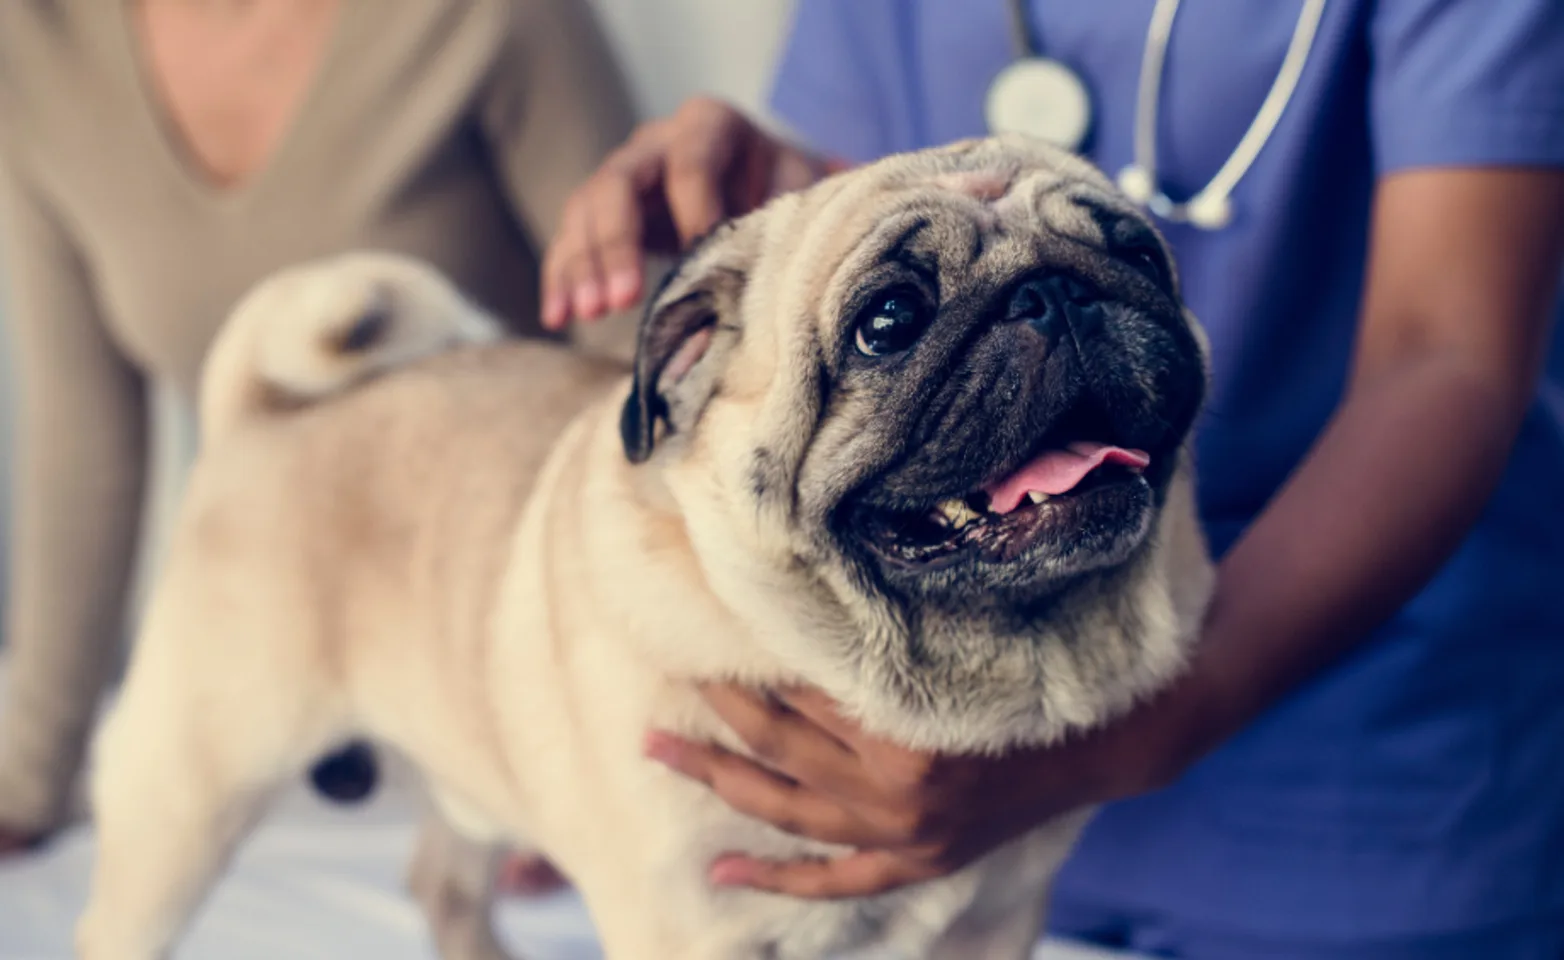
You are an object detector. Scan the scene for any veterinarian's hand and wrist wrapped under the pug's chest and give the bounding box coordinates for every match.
[646,686,1213,899]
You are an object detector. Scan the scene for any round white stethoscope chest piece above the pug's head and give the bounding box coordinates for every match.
[984,56,1092,150]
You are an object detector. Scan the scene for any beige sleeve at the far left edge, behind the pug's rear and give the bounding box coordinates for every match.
[0,155,147,830]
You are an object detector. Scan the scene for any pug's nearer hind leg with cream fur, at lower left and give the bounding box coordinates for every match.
[77,585,341,960]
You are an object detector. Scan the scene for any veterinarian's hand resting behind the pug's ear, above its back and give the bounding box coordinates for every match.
[543,97,834,330]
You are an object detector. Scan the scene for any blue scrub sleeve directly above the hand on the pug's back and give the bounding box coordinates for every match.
[771,0,924,163]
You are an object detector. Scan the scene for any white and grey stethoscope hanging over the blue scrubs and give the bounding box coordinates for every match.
[985,0,1325,230]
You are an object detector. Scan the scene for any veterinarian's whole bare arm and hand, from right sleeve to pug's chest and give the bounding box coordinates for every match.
[647,169,1564,897]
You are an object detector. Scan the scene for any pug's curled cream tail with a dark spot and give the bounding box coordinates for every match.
[200,252,500,441]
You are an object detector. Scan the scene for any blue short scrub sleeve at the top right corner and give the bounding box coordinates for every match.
[1369,0,1564,174]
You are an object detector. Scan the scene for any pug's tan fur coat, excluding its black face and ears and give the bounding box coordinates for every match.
[80,142,1211,960]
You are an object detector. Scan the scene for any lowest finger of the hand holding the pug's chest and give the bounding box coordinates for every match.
[708,851,943,901]
